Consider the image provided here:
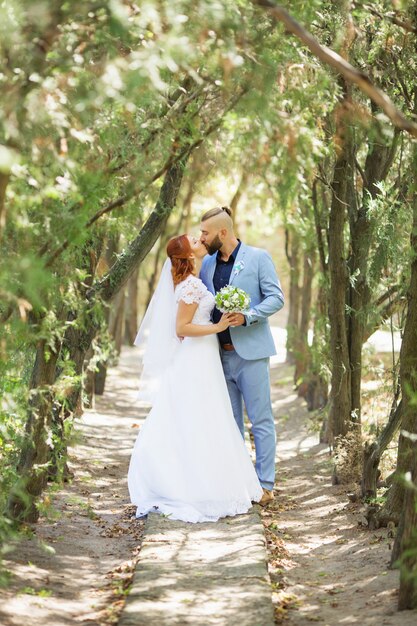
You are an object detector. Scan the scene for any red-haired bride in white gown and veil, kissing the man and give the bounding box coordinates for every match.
[128,235,263,522]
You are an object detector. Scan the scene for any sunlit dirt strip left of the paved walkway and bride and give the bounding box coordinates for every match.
[0,350,143,626]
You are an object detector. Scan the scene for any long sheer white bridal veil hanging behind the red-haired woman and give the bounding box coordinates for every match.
[134,259,181,404]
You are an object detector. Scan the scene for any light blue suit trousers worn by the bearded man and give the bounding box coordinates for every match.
[220,349,276,489]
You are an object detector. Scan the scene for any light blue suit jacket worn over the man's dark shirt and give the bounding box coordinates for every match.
[200,243,284,360]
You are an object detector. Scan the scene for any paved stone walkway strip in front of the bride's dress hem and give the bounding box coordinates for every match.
[119,506,274,626]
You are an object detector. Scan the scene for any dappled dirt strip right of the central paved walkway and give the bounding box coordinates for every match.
[263,365,417,626]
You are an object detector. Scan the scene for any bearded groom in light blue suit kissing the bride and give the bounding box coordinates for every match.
[200,207,284,506]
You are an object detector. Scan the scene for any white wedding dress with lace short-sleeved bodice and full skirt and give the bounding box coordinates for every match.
[128,276,263,522]
